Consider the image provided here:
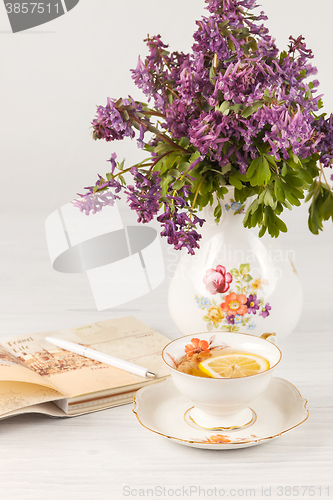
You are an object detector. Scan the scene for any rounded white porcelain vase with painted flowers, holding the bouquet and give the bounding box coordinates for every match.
[168,187,303,342]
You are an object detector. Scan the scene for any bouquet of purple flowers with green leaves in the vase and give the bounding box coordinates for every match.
[75,0,333,254]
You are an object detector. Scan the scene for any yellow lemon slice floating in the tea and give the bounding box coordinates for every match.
[199,353,269,378]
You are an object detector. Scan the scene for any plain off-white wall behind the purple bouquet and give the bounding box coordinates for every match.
[0,0,333,216]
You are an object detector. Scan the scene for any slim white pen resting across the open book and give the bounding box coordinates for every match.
[45,337,156,378]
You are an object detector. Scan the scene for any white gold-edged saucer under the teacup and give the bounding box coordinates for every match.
[133,377,309,450]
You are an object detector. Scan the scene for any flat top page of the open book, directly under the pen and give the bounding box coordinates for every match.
[2,317,170,398]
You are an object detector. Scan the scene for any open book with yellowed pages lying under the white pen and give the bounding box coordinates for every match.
[0,316,170,419]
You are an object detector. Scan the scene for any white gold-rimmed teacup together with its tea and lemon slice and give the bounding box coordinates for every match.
[162,332,281,430]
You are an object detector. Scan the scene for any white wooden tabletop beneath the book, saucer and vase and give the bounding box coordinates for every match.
[0,208,333,500]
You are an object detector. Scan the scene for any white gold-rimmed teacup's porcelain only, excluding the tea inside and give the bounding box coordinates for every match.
[162,332,282,430]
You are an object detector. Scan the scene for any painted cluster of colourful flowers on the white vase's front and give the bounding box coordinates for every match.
[195,264,271,332]
